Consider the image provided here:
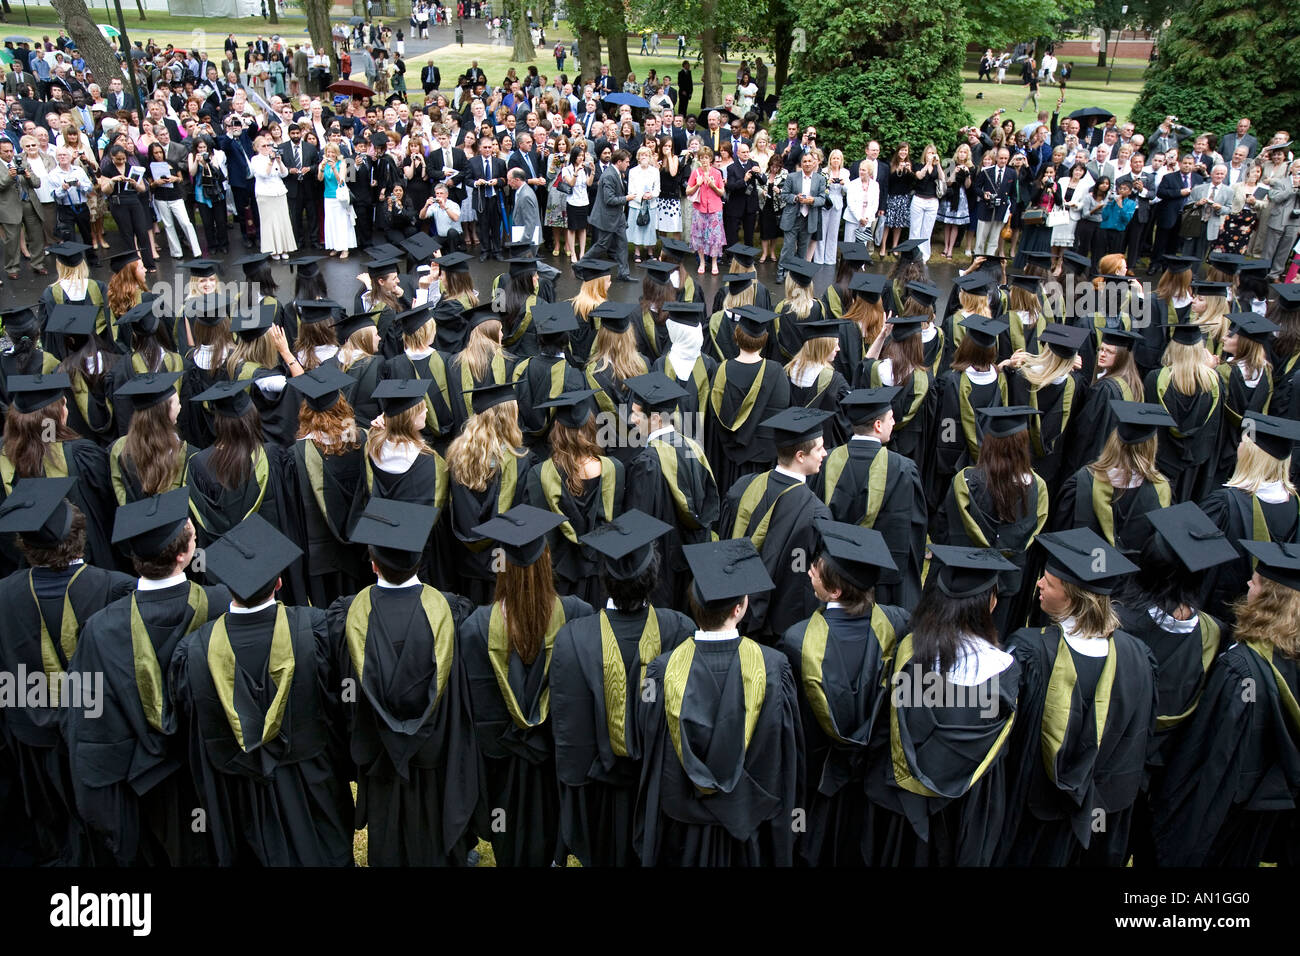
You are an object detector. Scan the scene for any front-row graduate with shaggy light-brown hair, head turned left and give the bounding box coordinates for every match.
[998,528,1156,866]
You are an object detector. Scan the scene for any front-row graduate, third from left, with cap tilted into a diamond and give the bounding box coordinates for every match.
[169,515,354,866]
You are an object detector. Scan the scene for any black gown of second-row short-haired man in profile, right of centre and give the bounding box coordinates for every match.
[718,471,831,645]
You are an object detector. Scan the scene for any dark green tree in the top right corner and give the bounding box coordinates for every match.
[1132,0,1300,142]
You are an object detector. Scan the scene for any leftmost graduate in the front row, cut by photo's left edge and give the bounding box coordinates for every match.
[0,477,135,866]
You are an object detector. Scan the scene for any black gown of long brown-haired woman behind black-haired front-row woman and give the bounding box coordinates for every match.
[935,468,1049,635]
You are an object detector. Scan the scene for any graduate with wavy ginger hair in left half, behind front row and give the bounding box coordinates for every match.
[283,364,368,607]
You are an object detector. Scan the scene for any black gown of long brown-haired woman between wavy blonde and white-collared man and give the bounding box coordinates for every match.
[524,455,627,606]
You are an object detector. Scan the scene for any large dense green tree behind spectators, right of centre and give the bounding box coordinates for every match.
[780,0,970,163]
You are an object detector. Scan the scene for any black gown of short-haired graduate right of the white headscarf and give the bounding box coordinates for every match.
[705,359,793,496]
